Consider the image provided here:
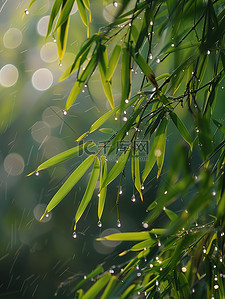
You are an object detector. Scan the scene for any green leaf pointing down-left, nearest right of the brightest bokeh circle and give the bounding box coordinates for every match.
[65,54,97,111]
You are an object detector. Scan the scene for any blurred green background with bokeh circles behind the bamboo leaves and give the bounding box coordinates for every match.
[0,0,224,298]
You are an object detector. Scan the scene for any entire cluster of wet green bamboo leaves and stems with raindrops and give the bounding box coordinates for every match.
[26,0,225,298]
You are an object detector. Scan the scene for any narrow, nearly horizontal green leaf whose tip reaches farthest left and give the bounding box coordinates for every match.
[27,142,96,176]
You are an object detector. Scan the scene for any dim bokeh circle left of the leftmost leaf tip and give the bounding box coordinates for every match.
[4,153,24,176]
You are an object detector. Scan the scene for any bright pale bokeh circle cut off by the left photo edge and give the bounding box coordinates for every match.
[0,64,19,87]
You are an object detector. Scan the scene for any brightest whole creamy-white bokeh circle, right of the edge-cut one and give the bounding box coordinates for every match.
[32,68,53,91]
